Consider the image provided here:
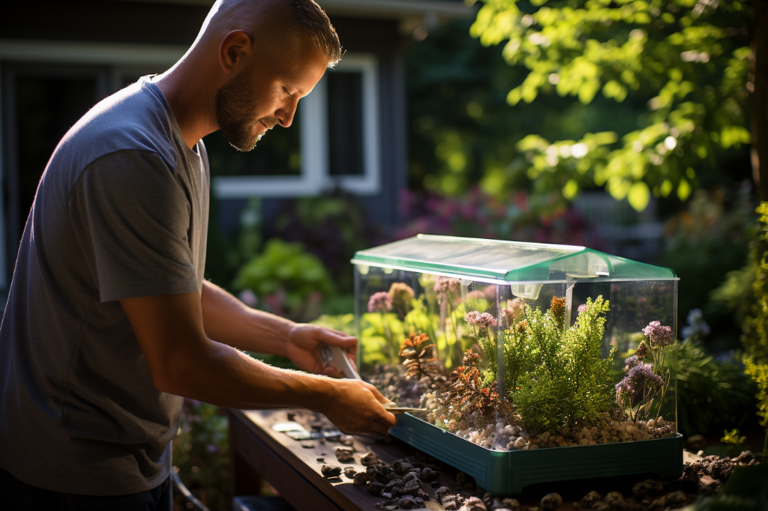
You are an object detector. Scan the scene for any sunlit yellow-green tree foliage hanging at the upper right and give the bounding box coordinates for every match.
[470,0,768,210]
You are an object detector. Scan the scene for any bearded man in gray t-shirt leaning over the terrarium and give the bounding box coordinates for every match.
[0,0,395,510]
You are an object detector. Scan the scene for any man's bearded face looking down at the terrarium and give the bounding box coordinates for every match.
[216,38,328,151]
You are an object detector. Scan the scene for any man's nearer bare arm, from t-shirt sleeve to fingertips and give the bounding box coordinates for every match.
[120,293,395,435]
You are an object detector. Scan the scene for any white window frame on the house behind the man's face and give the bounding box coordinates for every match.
[213,53,381,199]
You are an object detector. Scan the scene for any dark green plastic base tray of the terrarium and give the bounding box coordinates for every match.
[390,414,683,495]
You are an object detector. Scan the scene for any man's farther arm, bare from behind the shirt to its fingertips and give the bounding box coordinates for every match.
[196,281,357,375]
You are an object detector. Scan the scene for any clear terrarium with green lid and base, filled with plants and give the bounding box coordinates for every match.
[352,235,682,494]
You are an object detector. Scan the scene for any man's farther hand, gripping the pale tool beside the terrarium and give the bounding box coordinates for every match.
[285,324,357,376]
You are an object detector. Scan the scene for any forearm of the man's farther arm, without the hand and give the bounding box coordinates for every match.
[201,281,295,356]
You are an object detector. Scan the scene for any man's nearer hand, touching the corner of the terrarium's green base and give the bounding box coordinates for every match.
[319,379,397,436]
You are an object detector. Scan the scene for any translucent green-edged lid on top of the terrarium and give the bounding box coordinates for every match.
[352,234,677,282]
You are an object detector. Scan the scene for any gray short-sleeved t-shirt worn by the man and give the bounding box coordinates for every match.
[0,77,210,495]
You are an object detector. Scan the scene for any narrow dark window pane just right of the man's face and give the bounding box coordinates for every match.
[327,71,365,176]
